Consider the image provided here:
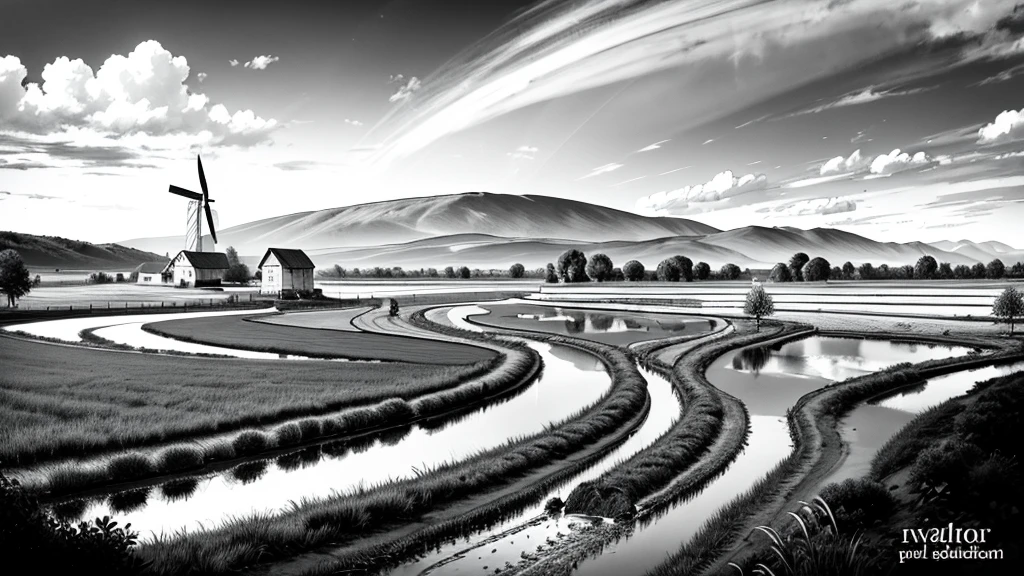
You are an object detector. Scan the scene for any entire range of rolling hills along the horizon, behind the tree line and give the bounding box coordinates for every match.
[117,193,1024,269]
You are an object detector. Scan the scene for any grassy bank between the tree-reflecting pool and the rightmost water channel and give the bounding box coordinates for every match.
[650,333,1021,576]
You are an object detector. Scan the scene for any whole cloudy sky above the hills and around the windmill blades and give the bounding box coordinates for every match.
[0,0,1024,247]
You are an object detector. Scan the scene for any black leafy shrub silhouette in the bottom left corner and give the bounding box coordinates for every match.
[0,474,144,575]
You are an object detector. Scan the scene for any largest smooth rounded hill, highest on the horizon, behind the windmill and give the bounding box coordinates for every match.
[121,192,720,255]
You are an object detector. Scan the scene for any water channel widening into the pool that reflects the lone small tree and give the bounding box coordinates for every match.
[575,336,968,575]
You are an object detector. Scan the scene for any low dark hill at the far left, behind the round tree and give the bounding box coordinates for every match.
[0,232,167,270]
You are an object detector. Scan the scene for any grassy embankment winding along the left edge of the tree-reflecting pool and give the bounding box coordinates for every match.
[520,323,815,576]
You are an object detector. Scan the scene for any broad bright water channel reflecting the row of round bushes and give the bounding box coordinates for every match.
[72,343,610,536]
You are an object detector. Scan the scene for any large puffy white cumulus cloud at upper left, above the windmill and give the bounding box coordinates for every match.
[0,40,279,152]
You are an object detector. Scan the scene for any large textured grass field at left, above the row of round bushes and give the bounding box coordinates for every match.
[0,334,497,465]
